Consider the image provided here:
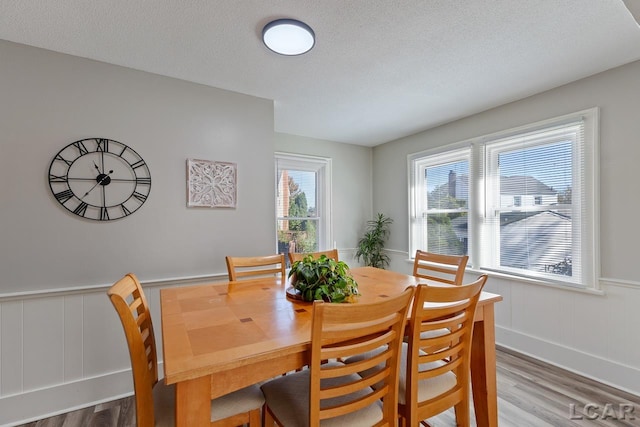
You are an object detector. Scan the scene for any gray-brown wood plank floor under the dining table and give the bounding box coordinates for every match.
[13,348,640,427]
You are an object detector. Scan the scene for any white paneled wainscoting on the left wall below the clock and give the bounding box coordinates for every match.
[0,273,227,426]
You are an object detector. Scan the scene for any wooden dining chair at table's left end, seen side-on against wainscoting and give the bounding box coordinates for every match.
[107,273,264,427]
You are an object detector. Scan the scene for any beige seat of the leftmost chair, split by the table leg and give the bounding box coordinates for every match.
[153,380,264,427]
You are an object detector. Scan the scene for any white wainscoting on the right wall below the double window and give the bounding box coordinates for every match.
[488,279,640,396]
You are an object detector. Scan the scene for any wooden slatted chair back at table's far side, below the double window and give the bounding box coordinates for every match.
[413,250,469,285]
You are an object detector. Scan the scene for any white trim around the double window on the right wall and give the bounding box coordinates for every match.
[407,107,601,294]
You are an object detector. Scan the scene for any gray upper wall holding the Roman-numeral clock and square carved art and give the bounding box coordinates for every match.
[0,41,275,294]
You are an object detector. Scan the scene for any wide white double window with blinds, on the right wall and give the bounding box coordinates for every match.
[409,109,598,287]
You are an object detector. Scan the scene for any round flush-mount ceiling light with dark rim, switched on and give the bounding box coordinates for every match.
[262,19,316,56]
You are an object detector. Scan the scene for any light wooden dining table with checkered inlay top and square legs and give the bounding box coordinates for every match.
[160,267,502,427]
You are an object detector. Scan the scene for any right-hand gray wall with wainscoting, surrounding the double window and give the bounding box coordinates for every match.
[373,62,640,394]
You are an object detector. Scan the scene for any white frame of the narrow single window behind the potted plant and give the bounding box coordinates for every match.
[274,152,333,251]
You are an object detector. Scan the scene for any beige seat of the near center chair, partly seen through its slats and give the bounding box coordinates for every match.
[262,362,383,427]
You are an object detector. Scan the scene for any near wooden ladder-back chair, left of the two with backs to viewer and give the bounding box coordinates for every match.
[262,287,415,427]
